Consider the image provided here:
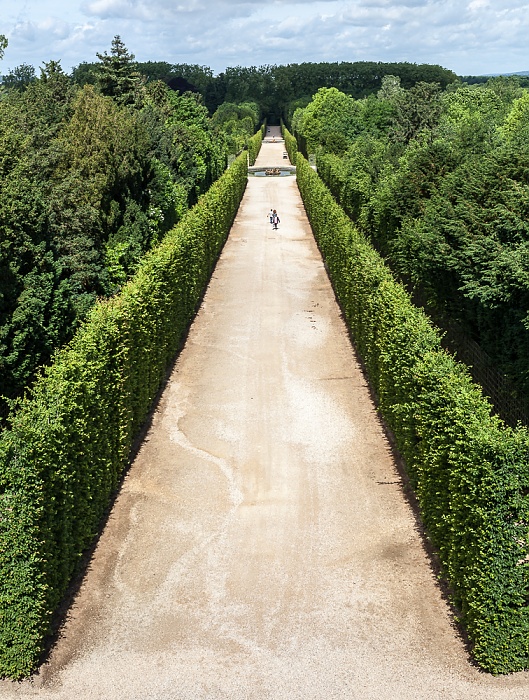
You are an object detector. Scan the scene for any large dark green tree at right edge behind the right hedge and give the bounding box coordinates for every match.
[393,143,529,388]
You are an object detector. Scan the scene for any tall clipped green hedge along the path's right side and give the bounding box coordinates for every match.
[296,154,529,674]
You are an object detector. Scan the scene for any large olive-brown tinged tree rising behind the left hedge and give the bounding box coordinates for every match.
[50,85,152,292]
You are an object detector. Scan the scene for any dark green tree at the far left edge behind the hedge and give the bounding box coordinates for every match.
[0,92,65,413]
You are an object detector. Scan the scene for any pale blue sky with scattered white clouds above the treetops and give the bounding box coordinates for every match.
[0,0,529,75]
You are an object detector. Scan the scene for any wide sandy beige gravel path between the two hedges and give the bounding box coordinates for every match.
[4,129,529,700]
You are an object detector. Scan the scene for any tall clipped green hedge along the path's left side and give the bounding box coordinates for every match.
[0,154,247,678]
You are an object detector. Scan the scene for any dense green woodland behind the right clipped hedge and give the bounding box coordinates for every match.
[292,76,529,408]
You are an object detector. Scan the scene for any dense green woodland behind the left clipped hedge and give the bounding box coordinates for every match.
[0,37,261,414]
